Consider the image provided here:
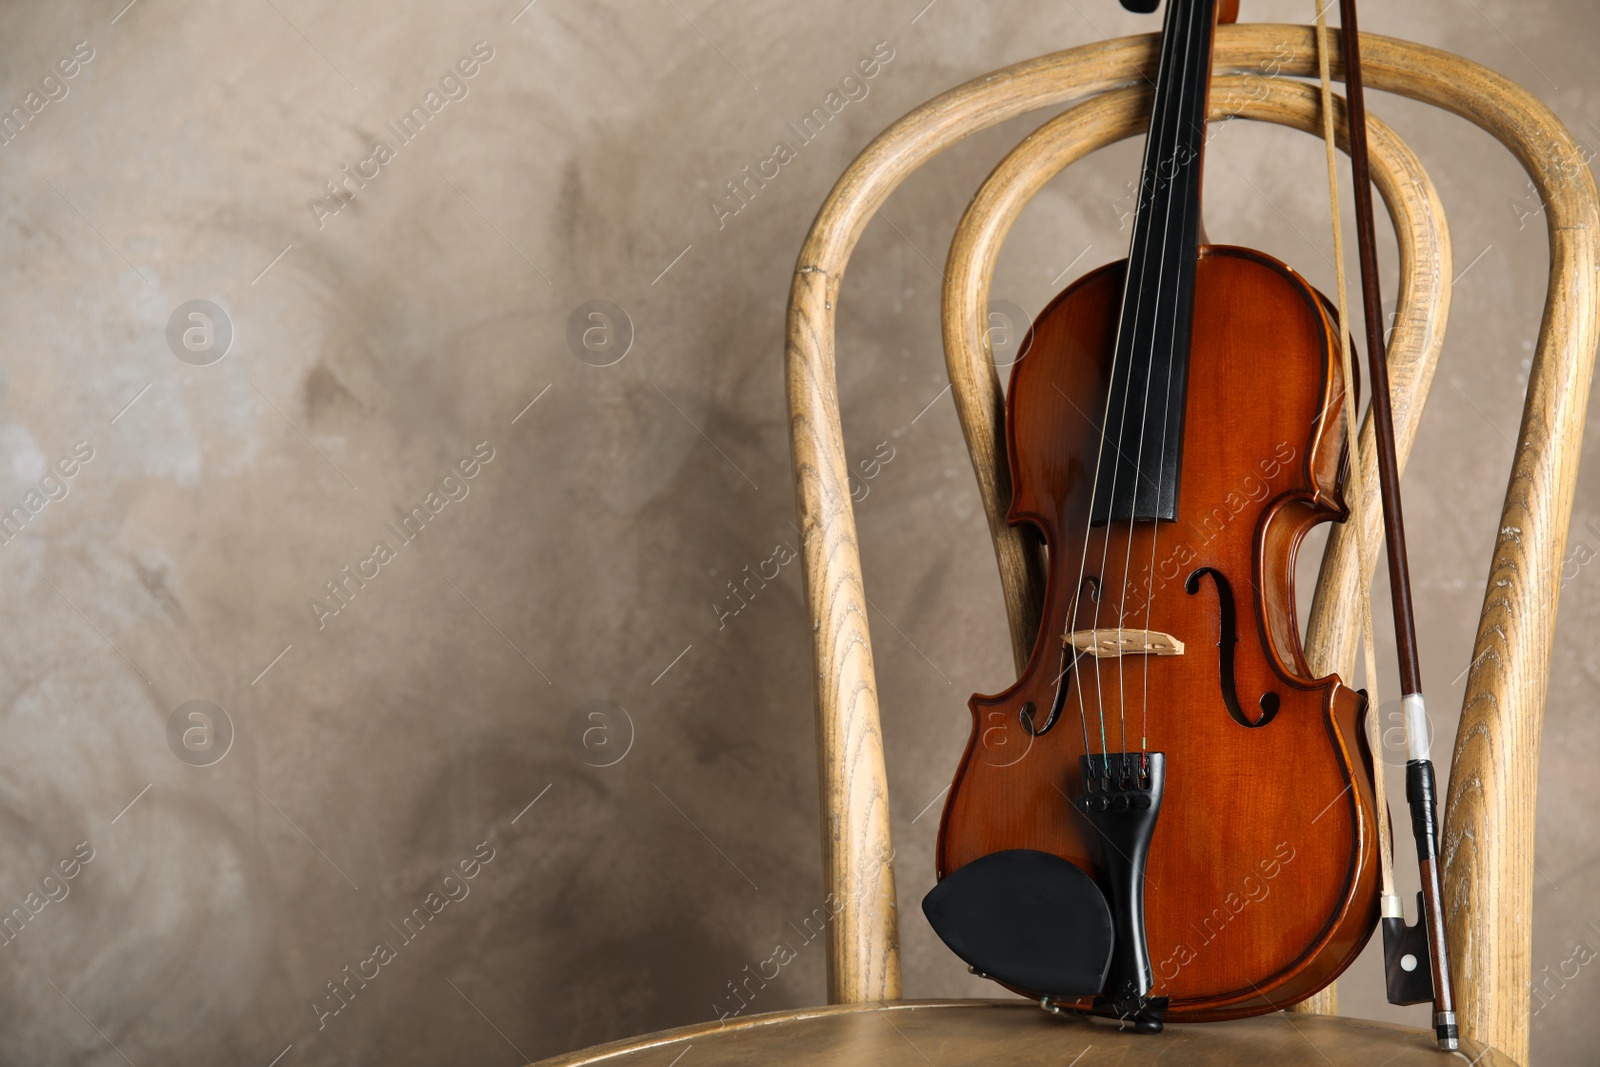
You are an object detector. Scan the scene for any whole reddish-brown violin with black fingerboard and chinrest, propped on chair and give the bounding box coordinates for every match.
[923,0,1379,1030]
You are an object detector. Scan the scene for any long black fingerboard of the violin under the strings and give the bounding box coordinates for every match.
[1091,0,1218,523]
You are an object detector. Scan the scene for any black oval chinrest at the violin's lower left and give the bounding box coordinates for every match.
[922,848,1112,997]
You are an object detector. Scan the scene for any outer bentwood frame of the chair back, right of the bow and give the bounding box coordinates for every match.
[1362,35,1600,1062]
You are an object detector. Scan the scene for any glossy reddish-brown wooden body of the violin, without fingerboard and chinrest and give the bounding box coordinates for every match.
[938,245,1378,1021]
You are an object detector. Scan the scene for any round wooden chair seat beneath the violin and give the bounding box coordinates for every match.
[539,1000,1515,1067]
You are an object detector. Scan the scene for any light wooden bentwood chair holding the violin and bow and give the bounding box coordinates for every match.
[546,24,1600,1067]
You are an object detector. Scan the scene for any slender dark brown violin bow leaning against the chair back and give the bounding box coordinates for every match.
[1317,0,1459,1051]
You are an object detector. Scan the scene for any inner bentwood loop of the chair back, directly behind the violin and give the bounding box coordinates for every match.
[942,85,1451,1014]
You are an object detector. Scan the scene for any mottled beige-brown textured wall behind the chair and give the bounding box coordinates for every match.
[0,0,1600,1067]
